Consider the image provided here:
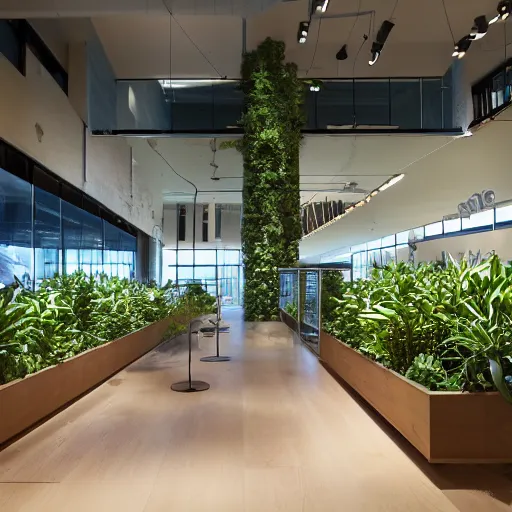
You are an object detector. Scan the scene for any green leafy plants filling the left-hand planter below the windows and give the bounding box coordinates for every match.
[0,272,215,384]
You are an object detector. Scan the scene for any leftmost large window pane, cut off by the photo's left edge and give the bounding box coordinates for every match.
[0,169,32,288]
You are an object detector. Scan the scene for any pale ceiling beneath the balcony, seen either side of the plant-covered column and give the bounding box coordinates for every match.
[127,135,452,208]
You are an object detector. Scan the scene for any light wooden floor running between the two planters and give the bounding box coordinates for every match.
[0,310,512,512]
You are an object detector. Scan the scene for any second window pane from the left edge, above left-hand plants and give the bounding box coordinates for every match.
[34,187,61,287]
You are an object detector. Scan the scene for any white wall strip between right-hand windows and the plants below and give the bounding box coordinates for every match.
[415,229,512,261]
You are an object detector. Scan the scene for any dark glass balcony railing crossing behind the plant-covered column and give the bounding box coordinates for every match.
[101,78,458,133]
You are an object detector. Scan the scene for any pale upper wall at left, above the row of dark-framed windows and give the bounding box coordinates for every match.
[0,51,162,235]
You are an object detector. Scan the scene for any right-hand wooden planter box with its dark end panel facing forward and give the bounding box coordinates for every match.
[320,331,512,463]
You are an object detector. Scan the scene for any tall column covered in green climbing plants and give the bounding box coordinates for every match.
[236,38,305,321]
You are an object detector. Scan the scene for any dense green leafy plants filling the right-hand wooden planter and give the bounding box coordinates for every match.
[324,255,512,402]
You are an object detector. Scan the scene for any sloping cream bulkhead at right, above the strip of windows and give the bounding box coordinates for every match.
[300,115,512,263]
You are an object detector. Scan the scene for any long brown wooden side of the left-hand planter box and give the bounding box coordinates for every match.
[0,318,183,444]
